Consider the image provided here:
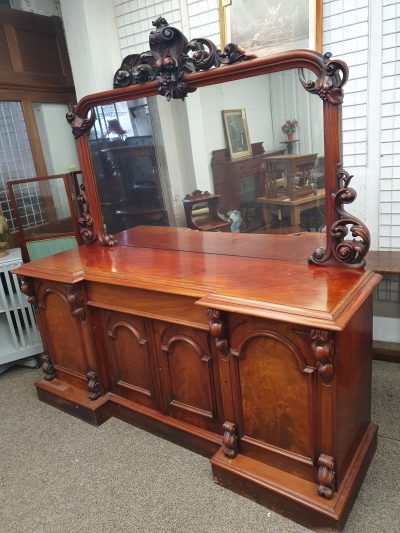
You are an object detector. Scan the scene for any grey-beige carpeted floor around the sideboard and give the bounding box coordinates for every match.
[0,362,400,533]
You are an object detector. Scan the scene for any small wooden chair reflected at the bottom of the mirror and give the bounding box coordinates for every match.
[183,190,231,231]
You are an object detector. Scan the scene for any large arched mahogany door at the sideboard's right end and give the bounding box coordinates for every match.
[230,317,318,478]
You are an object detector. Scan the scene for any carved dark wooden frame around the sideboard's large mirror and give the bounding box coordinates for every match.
[67,17,370,268]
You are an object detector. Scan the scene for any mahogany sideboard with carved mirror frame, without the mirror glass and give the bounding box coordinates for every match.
[18,18,380,530]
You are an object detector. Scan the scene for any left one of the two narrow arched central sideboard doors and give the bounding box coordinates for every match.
[99,311,157,407]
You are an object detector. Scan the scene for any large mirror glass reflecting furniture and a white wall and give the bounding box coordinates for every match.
[89,69,325,246]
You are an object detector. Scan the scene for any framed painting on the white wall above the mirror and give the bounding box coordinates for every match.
[219,0,322,56]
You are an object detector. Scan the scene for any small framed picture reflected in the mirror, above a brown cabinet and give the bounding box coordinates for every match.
[222,109,253,159]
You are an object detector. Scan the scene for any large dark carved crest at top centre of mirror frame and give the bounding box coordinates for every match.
[114,17,248,100]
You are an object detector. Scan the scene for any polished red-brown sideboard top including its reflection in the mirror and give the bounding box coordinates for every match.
[16,227,380,330]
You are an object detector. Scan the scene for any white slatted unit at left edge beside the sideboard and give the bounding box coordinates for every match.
[0,248,43,373]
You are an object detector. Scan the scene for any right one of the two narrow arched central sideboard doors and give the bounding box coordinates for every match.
[153,322,222,432]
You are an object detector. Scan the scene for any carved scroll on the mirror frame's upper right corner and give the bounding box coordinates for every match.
[299,52,349,105]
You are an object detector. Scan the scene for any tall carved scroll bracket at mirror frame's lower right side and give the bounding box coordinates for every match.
[309,162,371,268]
